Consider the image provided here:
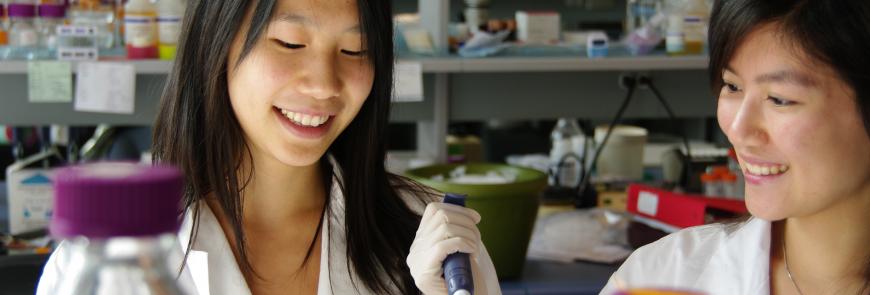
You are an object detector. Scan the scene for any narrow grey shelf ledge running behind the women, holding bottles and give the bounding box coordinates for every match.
[0,55,708,74]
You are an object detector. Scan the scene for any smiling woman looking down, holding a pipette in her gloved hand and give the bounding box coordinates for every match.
[39,0,500,294]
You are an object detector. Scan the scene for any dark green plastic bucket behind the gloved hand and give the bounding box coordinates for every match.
[405,163,547,279]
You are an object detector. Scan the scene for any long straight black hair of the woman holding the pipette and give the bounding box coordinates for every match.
[153,0,426,294]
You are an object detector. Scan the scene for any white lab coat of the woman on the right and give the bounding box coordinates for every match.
[601,218,771,295]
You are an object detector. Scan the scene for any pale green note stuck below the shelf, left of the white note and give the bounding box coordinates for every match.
[27,61,72,103]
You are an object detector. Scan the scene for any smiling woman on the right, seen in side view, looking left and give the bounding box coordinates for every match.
[603,0,870,295]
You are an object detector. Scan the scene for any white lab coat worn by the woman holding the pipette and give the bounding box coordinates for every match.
[36,162,500,295]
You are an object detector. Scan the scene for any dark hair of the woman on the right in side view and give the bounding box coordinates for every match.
[709,0,870,292]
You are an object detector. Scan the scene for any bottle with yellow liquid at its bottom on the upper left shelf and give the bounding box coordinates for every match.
[157,0,184,60]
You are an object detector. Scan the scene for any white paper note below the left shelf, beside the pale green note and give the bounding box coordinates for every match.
[74,62,136,114]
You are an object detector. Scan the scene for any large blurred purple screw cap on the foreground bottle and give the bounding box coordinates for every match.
[51,162,183,238]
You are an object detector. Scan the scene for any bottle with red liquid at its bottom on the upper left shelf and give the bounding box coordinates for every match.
[124,0,157,59]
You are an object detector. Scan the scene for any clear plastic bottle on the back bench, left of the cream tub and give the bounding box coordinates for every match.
[550,118,586,187]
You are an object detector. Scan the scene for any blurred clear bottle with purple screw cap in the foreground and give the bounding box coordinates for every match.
[47,163,183,294]
